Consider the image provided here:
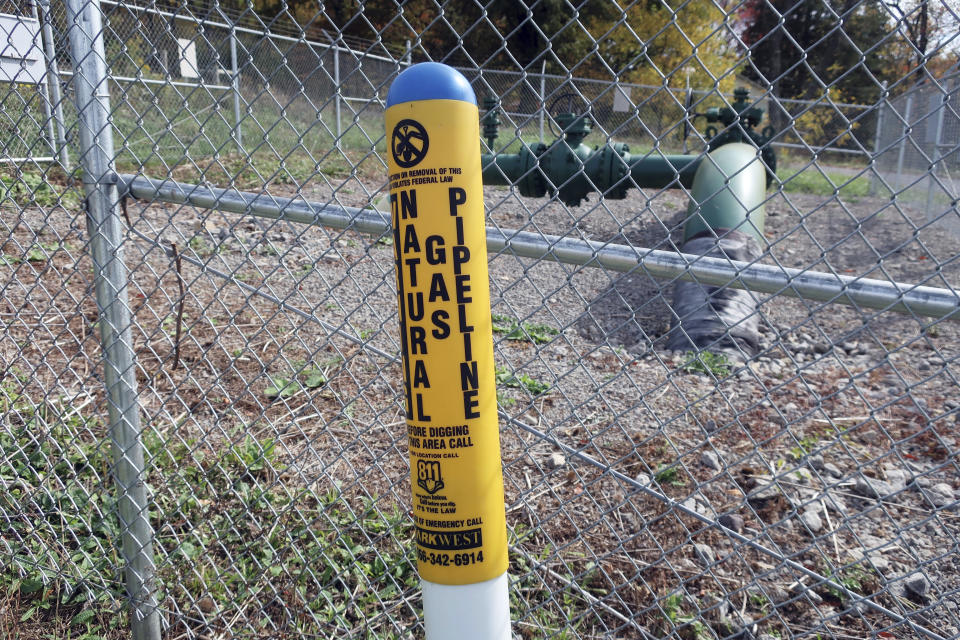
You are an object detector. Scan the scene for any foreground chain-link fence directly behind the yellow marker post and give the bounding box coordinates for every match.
[0,0,960,640]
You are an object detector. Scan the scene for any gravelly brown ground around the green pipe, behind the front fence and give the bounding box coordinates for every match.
[0,168,960,639]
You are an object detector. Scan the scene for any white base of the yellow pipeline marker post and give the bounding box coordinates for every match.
[422,572,511,640]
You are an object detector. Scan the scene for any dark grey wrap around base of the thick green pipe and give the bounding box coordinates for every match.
[667,230,761,355]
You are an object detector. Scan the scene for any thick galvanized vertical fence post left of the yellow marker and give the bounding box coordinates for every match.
[66,0,160,640]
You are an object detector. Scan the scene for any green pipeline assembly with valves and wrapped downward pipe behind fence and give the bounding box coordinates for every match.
[482,90,776,354]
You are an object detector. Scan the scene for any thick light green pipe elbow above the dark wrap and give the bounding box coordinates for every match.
[683,142,767,246]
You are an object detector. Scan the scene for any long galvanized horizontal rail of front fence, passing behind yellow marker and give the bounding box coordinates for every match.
[119,174,960,320]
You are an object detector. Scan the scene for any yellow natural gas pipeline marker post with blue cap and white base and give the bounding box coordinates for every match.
[386,62,510,640]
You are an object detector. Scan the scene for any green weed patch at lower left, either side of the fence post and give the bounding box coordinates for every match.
[0,381,419,640]
